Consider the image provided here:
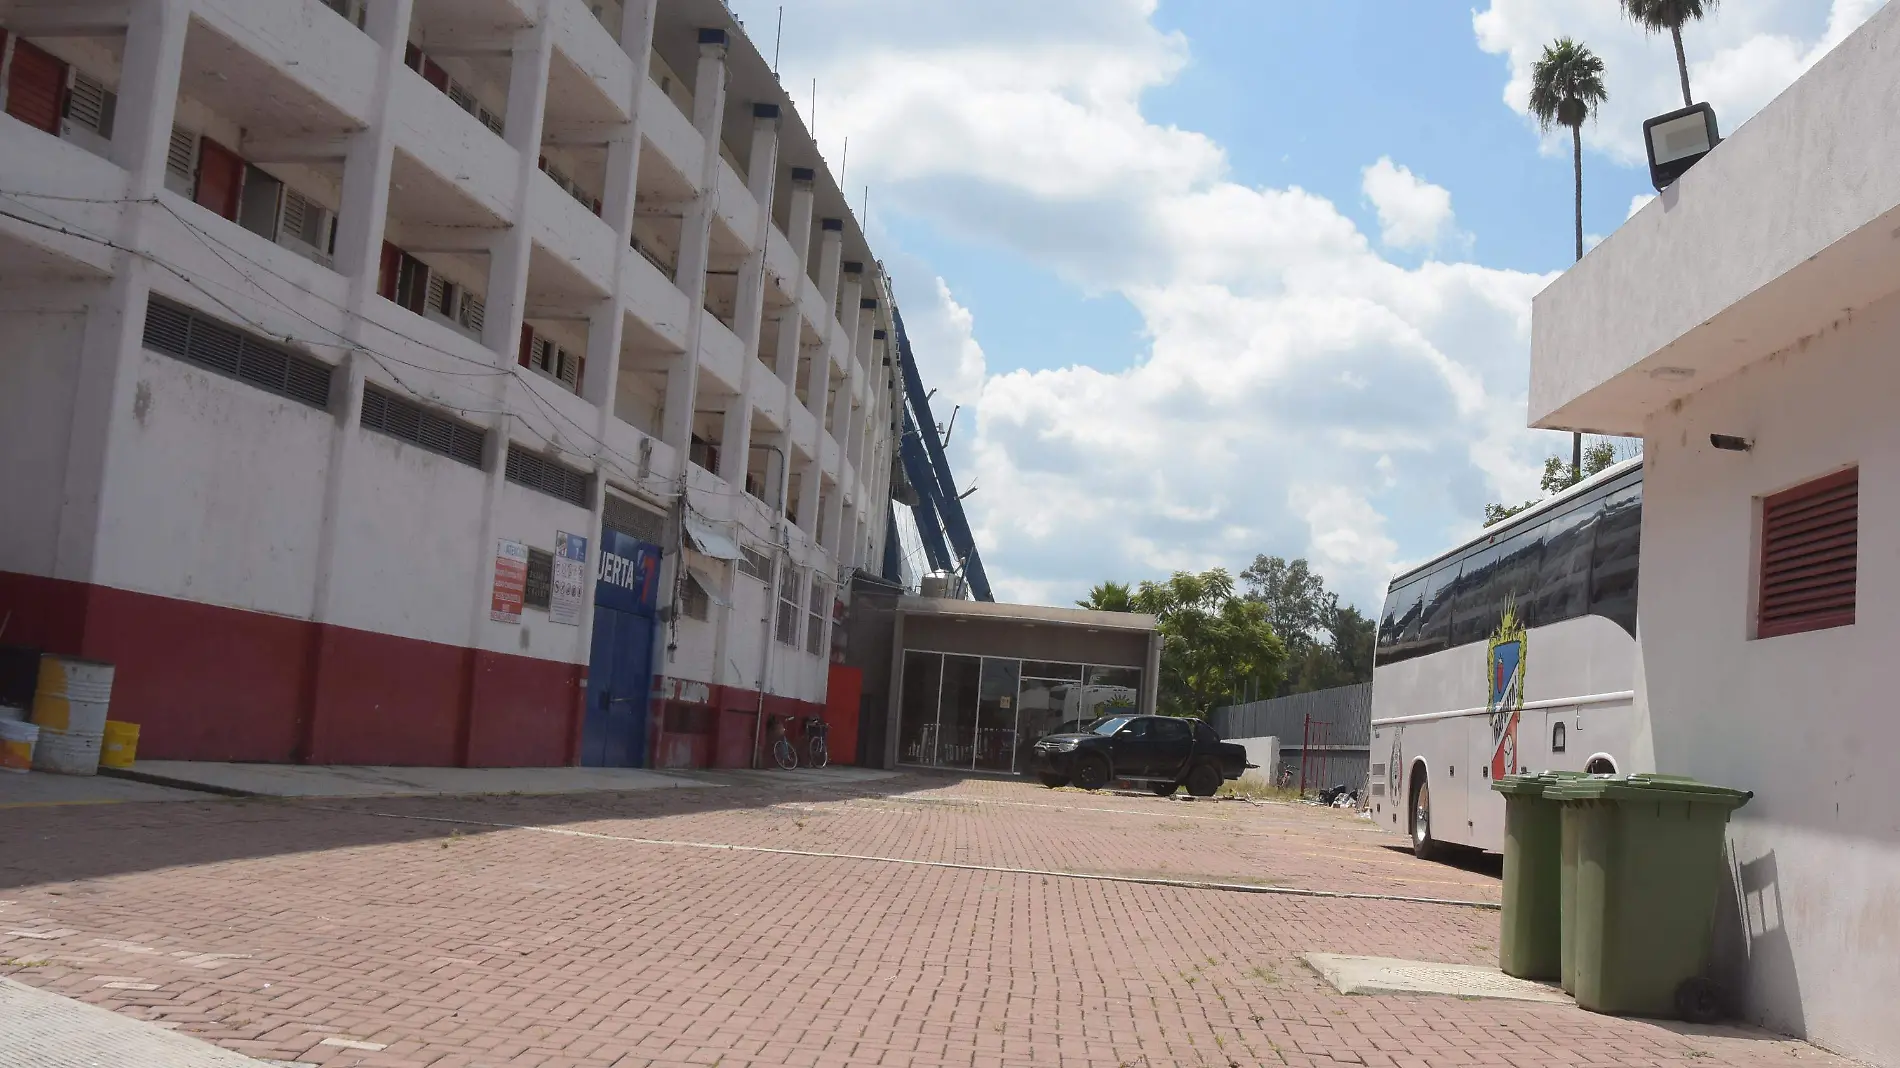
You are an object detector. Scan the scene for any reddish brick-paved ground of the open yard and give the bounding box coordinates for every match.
[0,777,1845,1068]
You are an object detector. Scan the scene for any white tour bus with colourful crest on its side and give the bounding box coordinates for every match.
[1368,458,1655,857]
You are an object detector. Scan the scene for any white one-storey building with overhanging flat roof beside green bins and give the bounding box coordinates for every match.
[1530,6,1900,1064]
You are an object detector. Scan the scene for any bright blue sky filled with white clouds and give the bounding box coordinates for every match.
[732,0,1883,612]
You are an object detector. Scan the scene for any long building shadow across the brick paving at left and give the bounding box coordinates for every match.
[0,773,944,891]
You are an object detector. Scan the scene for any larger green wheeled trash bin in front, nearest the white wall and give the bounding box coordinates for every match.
[1545,775,1754,1020]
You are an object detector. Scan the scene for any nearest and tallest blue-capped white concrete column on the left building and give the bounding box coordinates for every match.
[661,29,726,452]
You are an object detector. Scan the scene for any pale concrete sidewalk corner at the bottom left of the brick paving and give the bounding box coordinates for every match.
[0,979,270,1068]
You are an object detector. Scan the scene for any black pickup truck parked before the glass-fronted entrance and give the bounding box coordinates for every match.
[1032,716,1252,798]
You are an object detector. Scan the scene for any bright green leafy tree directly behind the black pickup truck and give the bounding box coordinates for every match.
[1132,568,1286,718]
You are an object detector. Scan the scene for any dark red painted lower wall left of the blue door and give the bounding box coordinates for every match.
[0,572,583,768]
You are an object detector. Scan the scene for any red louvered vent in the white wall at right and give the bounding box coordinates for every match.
[1756,467,1860,639]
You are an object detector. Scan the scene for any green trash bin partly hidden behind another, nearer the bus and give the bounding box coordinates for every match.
[1492,772,1581,979]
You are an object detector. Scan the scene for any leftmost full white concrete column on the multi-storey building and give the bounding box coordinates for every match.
[53,0,192,582]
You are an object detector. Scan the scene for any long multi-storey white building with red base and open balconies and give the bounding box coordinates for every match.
[0,0,899,766]
